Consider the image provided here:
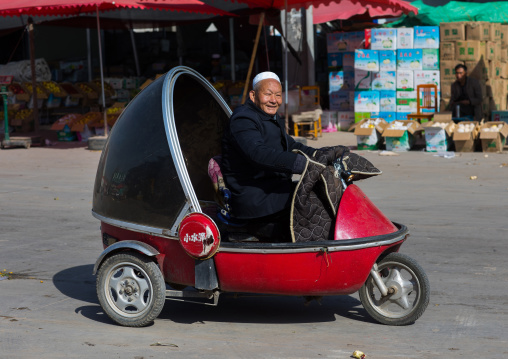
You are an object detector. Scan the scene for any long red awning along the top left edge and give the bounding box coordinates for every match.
[0,0,234,16]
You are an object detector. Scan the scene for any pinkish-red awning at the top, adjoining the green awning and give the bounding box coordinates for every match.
[312,0,418,24]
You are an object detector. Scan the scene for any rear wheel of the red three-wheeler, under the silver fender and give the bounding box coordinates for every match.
[96,252,166,327]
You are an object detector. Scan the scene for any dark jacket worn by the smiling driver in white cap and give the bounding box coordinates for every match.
[221,99,315,219]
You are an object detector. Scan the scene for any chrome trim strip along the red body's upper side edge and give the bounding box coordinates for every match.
[218,234,406,254]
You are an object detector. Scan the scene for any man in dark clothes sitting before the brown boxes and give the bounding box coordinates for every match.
[448,65,483,121]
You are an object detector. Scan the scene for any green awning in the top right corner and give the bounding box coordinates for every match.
[383,0,508,27]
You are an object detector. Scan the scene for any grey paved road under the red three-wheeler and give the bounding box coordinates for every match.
[0,134,508,359]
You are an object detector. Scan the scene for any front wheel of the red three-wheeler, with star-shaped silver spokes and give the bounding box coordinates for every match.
[359,253,430,325]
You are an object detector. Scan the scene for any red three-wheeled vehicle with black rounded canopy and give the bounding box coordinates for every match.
[92,67,430,327]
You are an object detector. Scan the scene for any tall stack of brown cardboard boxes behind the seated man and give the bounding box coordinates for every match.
[440,22,508,119]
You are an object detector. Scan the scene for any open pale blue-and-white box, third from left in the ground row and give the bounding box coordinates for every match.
[422,112,455,152]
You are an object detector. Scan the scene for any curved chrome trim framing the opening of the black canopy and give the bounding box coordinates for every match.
[162,66,231,225]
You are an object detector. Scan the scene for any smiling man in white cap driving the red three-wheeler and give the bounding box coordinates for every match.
[222,72,344,240]
